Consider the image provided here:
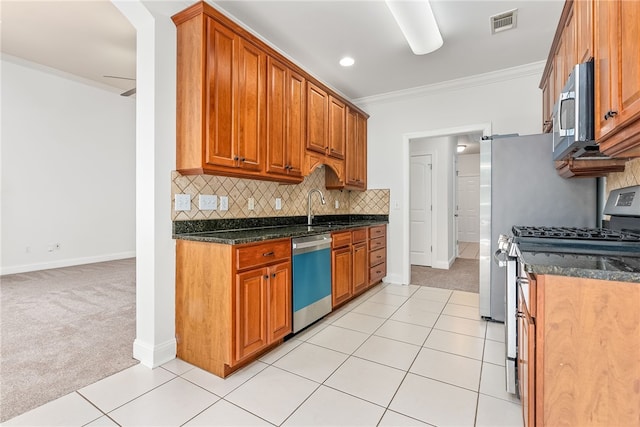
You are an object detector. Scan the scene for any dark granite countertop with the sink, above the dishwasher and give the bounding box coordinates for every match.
[173,215,389,245]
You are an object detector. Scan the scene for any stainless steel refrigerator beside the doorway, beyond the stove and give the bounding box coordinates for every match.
[480,134,600,321]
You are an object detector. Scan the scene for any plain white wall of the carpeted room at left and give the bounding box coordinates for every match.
[1,56,135,274]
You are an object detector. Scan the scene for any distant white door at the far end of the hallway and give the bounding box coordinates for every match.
[458,175,480,242]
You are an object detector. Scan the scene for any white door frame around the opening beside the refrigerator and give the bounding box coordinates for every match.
[401,122,491,284]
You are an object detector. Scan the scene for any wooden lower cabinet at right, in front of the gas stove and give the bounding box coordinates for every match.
[518,275,640,426]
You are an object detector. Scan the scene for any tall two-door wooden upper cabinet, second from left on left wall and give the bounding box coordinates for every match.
[266,57,306,182]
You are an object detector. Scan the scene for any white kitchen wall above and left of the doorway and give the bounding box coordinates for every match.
[356,63,544,284]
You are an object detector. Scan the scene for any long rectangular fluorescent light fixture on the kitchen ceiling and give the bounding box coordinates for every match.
[385,0,443,55]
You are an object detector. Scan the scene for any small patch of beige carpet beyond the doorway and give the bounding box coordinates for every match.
[411,258,480,293]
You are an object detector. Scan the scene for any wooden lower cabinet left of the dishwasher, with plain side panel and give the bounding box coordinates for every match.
[176,239,292,377]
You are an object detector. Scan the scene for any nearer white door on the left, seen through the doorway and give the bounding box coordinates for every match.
[409,155,432,266]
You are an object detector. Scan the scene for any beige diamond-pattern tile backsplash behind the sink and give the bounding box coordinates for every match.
[171,168,389,221]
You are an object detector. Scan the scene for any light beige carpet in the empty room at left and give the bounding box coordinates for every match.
[0,258,138,422]
